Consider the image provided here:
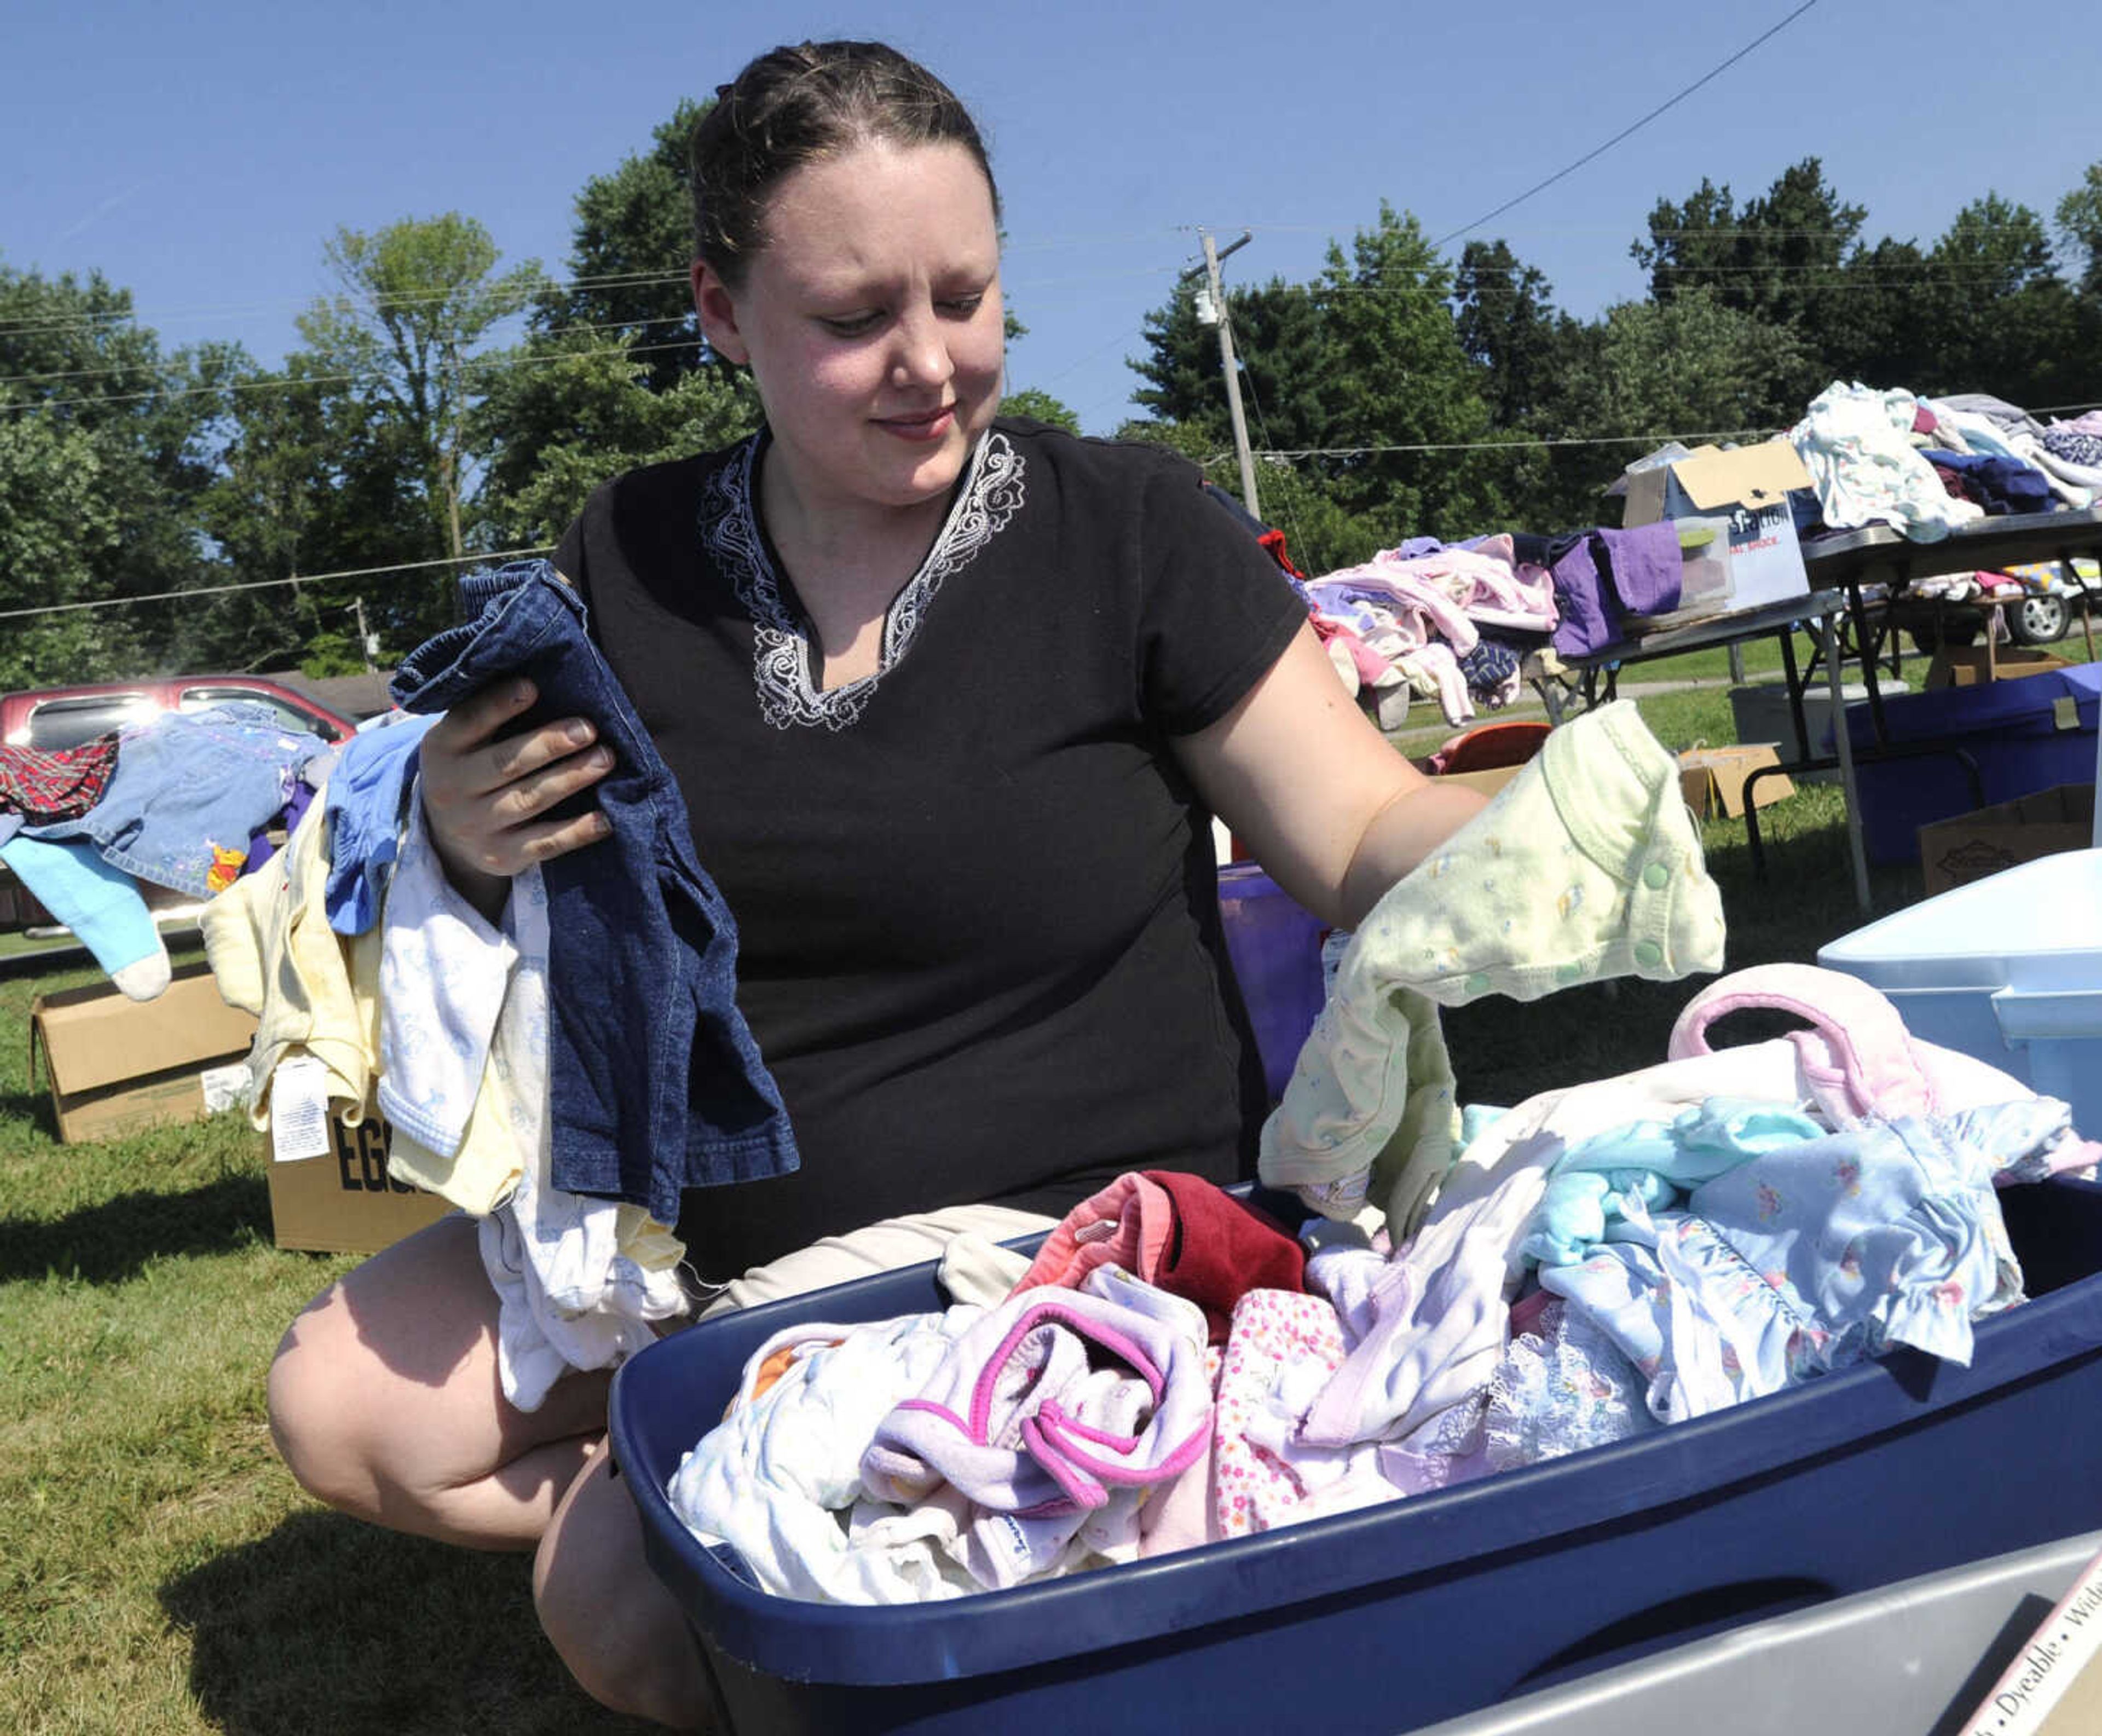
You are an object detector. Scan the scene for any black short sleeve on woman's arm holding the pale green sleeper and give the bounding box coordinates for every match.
[1139,460,1307,736]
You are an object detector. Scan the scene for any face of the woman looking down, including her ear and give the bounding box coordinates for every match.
[694,143,1005,517]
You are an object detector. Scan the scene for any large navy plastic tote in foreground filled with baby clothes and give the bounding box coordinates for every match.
[611,1181,2102,1736]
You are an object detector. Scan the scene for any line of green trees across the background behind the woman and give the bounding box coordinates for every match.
[0,103,2102,687]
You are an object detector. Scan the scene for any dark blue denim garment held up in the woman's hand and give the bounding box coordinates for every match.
[393,561,796,1223]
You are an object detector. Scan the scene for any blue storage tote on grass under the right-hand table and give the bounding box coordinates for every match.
[1846,664,2102,864]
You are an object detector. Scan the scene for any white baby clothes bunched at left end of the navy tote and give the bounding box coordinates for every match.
[666,1307,984,1604]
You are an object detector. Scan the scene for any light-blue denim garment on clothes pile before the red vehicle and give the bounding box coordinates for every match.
[21,700,322,897]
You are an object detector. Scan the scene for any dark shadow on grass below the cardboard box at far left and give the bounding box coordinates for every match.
[0,1175,269,1284]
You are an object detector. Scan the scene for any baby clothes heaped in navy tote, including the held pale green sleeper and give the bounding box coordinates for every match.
[666,704,2102,1604]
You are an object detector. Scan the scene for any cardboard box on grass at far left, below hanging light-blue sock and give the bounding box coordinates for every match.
[30,962,256,1145]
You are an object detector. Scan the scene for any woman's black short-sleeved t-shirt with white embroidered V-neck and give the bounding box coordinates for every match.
[557,410,1306,1280]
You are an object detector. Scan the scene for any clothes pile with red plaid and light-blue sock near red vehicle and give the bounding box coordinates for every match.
[0,700,336,1000]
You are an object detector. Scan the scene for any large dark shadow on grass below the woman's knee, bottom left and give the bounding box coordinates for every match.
[160,1511,656,1736]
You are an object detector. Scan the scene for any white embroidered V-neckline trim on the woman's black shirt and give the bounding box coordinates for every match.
[700,429,1026,729]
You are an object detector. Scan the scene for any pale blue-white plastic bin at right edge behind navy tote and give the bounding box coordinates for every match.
[1818,849,2102,1139]
